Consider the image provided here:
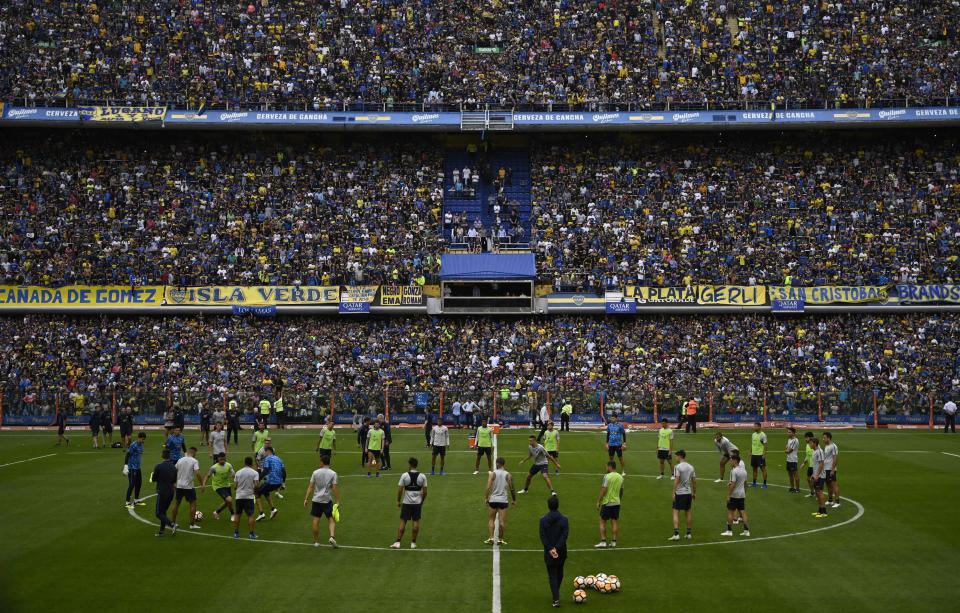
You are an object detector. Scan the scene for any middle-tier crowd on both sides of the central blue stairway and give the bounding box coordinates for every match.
[0,132,960,292]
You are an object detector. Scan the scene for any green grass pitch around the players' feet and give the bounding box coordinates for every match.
[0,430,960,612]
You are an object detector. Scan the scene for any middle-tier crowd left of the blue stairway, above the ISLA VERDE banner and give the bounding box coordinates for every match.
[0,133,443,285]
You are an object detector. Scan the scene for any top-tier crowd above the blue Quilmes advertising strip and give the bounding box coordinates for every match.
[0,0,960,109]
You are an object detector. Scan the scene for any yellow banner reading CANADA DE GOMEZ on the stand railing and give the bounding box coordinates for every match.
[0,285,164,308]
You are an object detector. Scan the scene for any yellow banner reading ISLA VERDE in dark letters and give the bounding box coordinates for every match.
[164,285,340,306]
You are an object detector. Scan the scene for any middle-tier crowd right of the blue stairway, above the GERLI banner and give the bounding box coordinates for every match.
[531,134,960,291]
